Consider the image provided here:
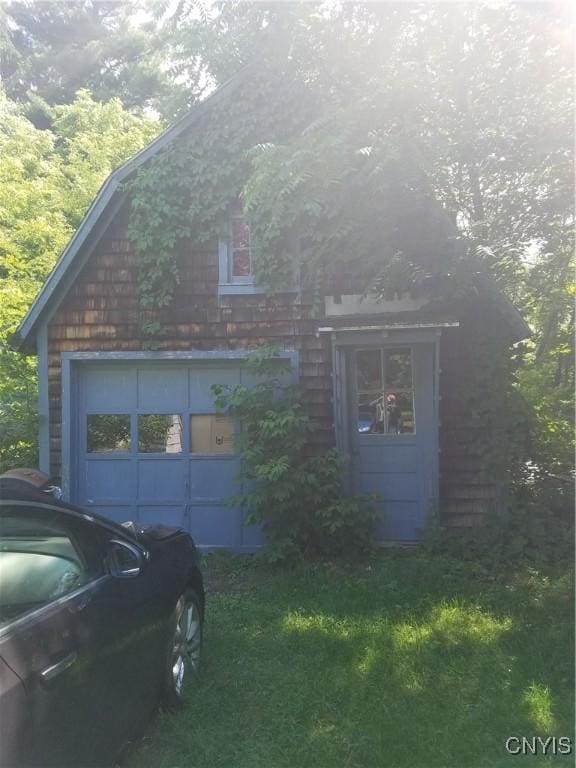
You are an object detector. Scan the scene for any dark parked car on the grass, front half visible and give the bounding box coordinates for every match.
[0,470,204,768]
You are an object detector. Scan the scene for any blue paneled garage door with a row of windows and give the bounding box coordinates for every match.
[71,361,262,550]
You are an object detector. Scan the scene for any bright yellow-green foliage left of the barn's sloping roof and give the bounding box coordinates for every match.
[0,91,159,469]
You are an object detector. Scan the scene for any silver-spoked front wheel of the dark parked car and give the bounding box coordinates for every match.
[163,589,202,707]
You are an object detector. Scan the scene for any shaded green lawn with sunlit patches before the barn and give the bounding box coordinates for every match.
[128,552,574,768]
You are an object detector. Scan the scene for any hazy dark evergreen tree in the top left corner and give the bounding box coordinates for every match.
[0,0,177,115]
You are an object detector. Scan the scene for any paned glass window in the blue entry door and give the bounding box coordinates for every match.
[356,347,416,435]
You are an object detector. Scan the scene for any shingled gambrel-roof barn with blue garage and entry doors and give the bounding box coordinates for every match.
[15,75,528,551]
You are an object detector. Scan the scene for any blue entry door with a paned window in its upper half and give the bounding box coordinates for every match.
[348,343,438,541]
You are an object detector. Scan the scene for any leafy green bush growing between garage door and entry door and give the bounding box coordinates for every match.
[212,351,379,559]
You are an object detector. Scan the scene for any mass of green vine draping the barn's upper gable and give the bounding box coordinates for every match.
[128,63,446,335]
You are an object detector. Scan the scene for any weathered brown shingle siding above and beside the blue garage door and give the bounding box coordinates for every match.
[48,222,334,475]
